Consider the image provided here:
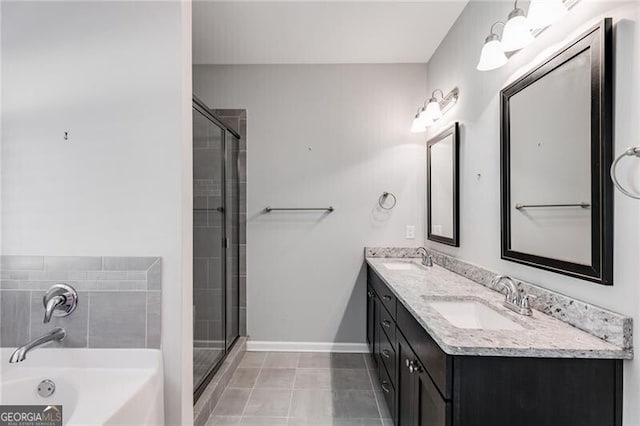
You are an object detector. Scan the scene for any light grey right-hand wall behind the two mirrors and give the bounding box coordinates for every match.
[427,1,640,426]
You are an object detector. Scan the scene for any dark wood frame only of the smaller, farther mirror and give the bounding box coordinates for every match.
[427,122,460,247]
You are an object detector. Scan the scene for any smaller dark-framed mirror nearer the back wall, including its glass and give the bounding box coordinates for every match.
[427,123,460,247]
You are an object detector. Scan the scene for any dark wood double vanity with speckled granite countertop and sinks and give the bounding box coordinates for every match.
[367,258,632,426]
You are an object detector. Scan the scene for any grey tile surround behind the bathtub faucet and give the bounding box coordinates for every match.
[0,256,162,348]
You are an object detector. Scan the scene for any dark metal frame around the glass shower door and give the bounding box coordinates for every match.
[191,95,241,405]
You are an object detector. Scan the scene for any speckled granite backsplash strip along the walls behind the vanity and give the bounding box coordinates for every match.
[365,247,633,351]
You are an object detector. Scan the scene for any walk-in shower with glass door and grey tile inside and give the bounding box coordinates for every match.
[193,97,240,400]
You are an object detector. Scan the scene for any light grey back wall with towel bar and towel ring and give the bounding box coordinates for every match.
[194,64,426,343]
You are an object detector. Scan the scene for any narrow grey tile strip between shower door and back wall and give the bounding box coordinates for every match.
[211,109,247,336]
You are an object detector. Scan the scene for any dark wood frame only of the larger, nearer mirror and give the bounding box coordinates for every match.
[500,18,613,285]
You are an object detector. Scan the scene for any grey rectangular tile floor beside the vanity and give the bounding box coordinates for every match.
[207,352,392,426]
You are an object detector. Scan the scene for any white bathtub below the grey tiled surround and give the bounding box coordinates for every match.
[0,348,164,426]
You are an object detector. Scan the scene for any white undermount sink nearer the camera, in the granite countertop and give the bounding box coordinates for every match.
[429,300,523,330]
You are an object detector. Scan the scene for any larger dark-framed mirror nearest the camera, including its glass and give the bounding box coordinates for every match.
[500,18,613,285]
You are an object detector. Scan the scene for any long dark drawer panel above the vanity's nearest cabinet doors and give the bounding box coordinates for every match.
[398,304,453,399]
